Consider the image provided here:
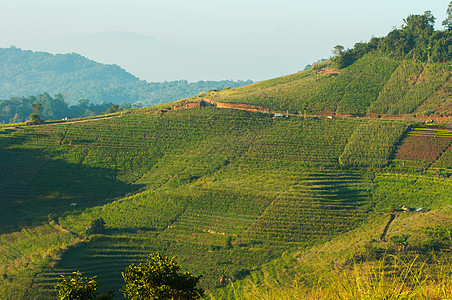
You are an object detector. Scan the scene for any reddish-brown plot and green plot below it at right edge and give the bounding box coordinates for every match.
[373,126,452,211]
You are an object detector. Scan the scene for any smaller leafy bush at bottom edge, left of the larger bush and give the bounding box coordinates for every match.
[55,271,97,300]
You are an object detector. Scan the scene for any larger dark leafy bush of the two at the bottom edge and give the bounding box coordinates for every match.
[122,252,204,300]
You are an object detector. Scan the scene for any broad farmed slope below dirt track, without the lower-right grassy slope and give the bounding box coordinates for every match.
[0,102,452,299]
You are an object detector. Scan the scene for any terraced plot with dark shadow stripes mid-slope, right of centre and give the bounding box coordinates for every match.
[246,171,368,248]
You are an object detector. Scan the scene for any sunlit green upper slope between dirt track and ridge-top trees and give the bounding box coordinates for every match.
[207,53,452,118]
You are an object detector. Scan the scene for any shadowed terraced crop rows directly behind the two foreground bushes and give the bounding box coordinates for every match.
[35,237,274,292]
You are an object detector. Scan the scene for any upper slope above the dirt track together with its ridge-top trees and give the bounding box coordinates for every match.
[208,11,452,117]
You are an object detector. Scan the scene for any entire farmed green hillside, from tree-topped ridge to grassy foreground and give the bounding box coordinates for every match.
[0,8,452,299]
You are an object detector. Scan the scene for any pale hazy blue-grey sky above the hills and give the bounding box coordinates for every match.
[0,0,450,81]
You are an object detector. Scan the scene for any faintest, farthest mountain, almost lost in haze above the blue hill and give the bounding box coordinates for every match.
[38,32,212,82]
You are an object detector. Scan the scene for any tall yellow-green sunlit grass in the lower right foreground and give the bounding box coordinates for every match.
[230,257,452,300]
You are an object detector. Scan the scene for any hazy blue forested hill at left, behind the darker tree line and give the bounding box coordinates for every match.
[0,47,252,105]
